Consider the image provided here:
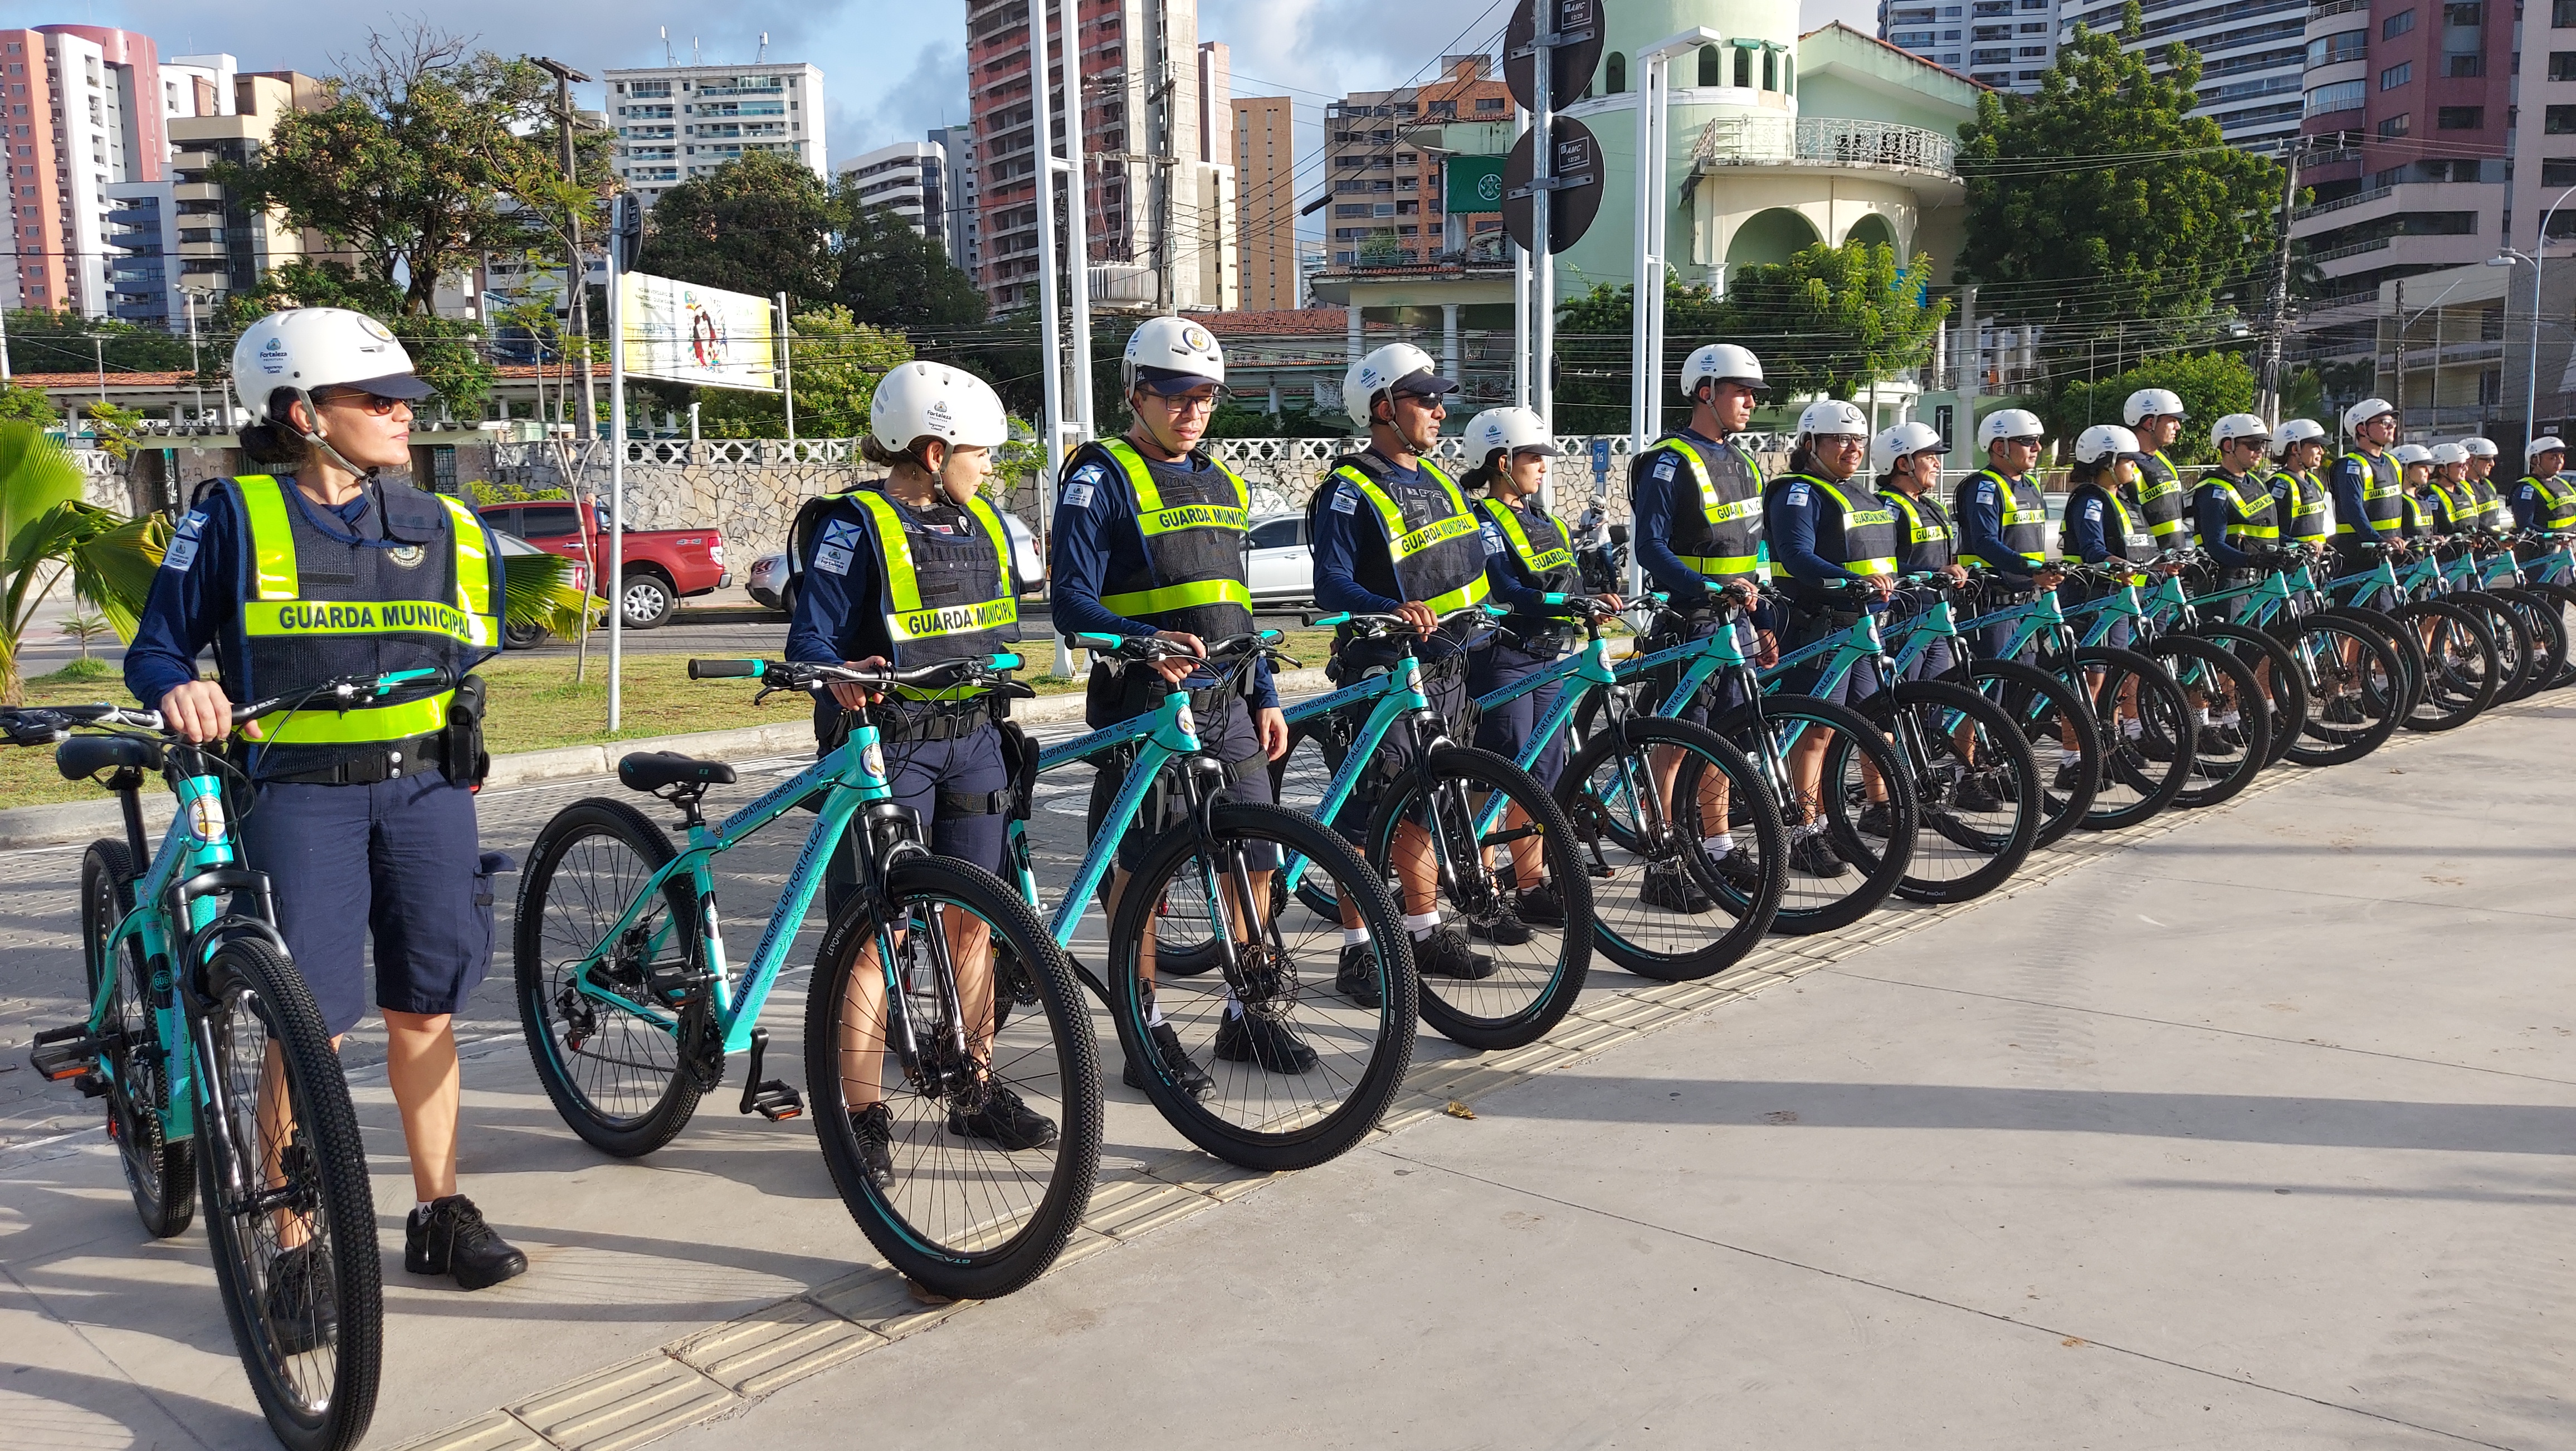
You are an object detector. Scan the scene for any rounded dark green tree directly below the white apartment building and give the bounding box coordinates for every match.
[636,152,842,306]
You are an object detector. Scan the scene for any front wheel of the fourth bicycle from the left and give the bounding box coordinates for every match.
[1368,745,1592,1051]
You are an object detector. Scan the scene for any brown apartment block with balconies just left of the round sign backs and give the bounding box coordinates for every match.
[1324,54,1504,268]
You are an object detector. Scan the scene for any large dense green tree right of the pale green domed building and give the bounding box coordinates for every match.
[1958,0,2282,320]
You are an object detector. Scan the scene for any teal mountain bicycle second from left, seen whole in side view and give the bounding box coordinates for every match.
[515,655,1102,1299]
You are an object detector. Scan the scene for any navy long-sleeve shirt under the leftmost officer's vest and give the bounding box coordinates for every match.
[124,474,508,709]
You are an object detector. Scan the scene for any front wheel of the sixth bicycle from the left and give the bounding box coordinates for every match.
[1718,696,1922,938]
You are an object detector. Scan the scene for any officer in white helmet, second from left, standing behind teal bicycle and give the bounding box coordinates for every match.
[786,361,1056,1183]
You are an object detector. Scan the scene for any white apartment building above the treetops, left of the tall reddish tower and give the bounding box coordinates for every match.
[606,62,832,206]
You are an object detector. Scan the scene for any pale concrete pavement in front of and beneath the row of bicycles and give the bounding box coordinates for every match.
[0,701,2576,1451]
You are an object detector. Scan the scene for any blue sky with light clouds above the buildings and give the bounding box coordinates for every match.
[65,0,1875,196]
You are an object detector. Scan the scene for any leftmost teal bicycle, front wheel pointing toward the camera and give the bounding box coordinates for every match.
[0,670,412,1451]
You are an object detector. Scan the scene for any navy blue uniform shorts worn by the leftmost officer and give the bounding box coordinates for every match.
[240,771,508,1036]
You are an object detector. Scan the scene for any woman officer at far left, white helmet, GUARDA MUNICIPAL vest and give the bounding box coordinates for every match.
[126,306,528,1289]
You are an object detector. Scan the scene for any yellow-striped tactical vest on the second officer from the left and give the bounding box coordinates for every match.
[824,490,1020,701]
